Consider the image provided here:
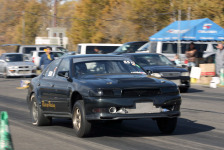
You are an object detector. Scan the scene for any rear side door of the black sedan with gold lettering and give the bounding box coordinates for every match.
[37,59,61,111]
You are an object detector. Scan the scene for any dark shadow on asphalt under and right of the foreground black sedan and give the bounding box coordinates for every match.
[50,118,215,138]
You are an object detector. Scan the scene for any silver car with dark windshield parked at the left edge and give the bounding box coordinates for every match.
[0,53,36,78]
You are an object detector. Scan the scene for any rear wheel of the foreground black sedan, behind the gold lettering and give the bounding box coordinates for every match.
[30,94,52,126]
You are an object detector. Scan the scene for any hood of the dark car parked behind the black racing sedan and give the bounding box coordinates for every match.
[143,66,187,73]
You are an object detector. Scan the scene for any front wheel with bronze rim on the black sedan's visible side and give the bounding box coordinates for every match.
[72,100,92,137]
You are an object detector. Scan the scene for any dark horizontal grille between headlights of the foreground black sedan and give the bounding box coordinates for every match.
[122,89,161,97]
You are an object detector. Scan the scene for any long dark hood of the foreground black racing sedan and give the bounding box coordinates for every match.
[73,74,176,88]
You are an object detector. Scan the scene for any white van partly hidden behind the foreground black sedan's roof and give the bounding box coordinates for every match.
[77,43,122,54]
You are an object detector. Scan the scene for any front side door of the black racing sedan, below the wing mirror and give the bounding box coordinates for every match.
[54,58,71,112]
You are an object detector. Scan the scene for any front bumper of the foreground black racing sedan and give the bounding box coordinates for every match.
[84,95,181,120]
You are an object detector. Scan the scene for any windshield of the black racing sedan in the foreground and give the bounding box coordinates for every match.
[73,60,145,77]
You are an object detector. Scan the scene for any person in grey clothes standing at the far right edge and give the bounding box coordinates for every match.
[215,43,224,76]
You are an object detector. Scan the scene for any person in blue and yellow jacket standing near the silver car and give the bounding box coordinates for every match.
[40,47,54,70]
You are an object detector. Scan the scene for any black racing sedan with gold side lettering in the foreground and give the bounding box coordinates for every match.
[27,54,181,137]
